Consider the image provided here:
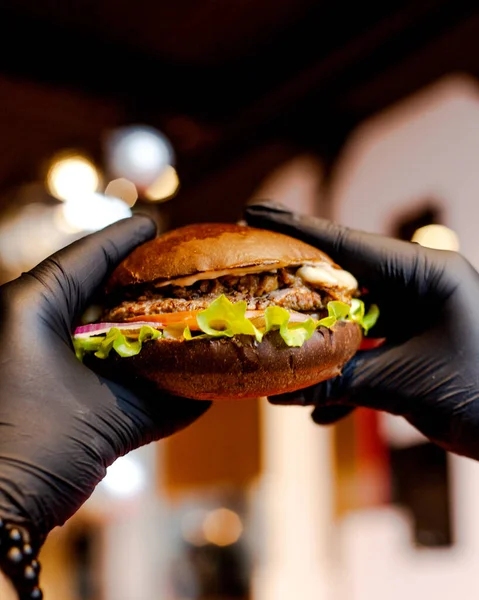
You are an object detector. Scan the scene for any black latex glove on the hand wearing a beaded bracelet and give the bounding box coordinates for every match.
[0,216,209,536]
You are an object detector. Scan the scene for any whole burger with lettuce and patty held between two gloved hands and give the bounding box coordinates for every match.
[73,223,378,400]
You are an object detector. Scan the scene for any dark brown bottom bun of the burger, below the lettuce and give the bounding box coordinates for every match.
[85,321,362,400]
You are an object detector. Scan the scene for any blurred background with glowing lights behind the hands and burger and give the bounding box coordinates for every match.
[0,0,479,600]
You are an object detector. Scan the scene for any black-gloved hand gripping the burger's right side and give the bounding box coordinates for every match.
[245,203,479,459]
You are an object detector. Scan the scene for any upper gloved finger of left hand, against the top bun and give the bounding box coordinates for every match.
[29,215,156,322]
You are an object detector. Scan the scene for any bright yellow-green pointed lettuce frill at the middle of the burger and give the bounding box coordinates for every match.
[196,294,263,342]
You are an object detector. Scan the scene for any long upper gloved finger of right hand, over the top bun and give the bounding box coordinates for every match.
[245,202,434,282]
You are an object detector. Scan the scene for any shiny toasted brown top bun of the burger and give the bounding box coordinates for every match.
[107,223,334,291]
